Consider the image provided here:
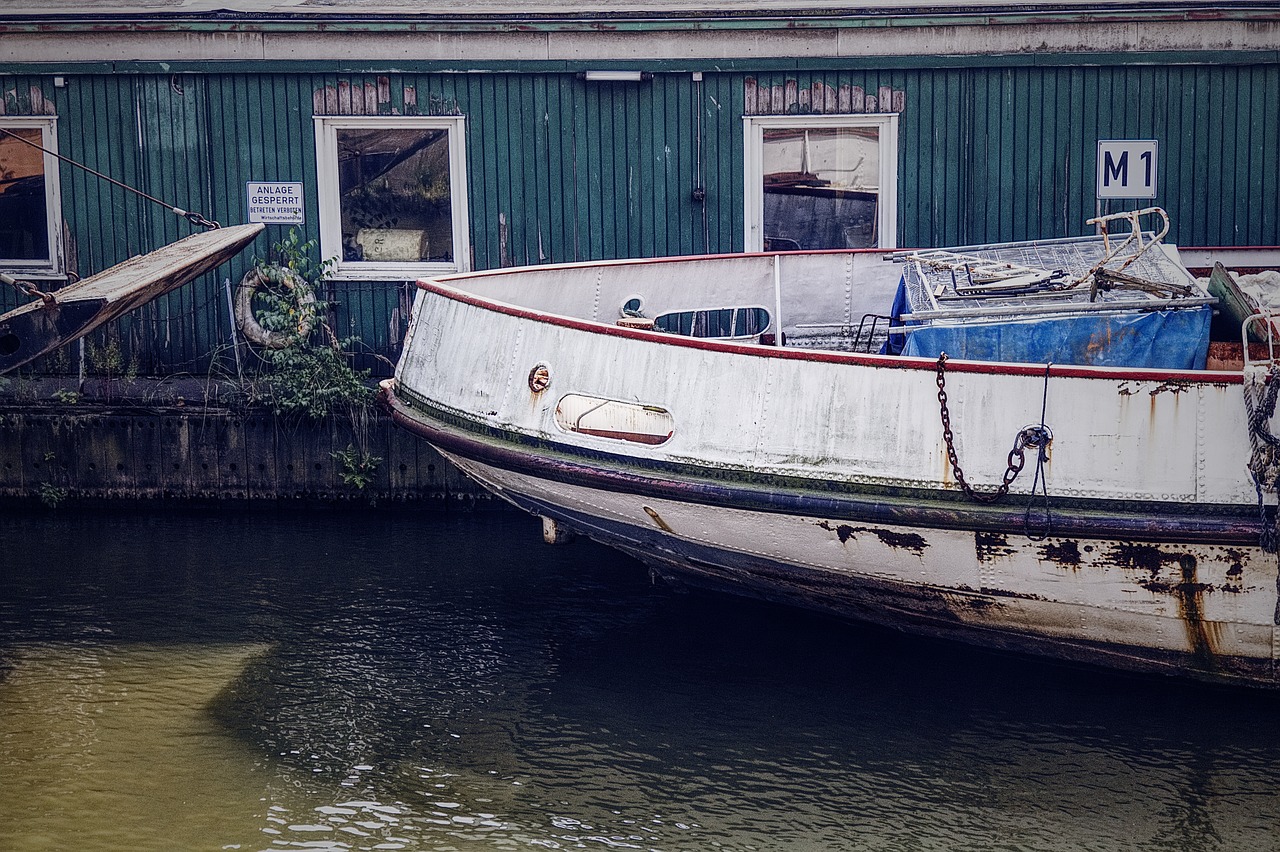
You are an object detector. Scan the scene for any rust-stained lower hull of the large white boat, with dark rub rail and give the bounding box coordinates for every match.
[383,385,1277,686]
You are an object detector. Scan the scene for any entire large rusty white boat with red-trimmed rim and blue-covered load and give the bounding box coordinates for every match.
[383,211,1280,686]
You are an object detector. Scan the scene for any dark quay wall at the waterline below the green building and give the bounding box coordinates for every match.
[0,402,494,508]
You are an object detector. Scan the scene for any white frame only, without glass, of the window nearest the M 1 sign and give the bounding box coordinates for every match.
[742,113,897,252]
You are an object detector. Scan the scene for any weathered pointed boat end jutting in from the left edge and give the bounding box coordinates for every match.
[0,224,265,374]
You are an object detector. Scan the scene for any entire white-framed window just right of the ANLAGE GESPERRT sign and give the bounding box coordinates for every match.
[316,116,471,279]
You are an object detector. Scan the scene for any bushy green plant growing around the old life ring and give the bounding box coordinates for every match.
[251,228,372,418]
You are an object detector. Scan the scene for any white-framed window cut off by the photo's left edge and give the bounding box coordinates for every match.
[0,118,63,275]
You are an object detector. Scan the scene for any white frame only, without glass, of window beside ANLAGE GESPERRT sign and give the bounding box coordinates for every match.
[315,115,471,280]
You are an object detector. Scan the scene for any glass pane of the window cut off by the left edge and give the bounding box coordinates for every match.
[0,127,51,264]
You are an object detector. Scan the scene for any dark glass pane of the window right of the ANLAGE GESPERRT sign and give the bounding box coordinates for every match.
[337,128,453,264]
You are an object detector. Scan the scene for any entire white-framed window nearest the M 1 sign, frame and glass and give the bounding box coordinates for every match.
[744,114,897,251]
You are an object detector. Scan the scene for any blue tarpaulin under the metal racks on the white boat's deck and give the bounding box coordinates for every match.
[882,277,1213,370]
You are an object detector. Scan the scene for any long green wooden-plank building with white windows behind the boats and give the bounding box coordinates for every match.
[0,0,1280,375]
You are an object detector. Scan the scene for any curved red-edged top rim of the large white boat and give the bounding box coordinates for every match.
[416,248,1244,386]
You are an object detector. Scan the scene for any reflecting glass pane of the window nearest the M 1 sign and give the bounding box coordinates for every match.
[762,127,881,251]
